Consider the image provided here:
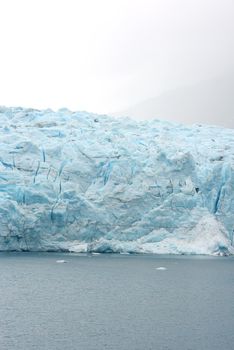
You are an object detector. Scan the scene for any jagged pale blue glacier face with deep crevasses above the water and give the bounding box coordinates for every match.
[0,107,234,254]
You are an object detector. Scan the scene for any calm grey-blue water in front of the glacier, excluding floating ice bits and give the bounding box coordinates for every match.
[0,253,234,350]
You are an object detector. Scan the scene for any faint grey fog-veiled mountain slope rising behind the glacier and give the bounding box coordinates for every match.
[119,74,234,128]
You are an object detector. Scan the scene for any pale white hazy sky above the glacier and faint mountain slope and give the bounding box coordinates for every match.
[0,0,234,118]
